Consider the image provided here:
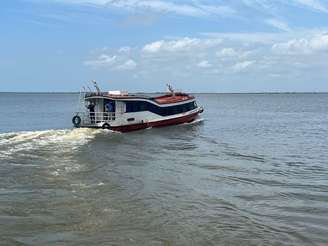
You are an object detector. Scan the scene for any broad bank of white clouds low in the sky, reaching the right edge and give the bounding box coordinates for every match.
[86,30,328,87]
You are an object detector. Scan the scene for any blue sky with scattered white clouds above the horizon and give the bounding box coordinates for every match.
[0,0,328,92]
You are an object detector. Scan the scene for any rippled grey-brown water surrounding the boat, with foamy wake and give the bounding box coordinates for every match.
[0,94,328,246]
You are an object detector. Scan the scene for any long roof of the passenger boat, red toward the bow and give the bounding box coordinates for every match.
[85,92,194,104]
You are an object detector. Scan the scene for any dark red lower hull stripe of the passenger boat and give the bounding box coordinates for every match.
[110,111,199,132]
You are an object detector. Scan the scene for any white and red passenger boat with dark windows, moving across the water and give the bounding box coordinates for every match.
[72,81,203,132]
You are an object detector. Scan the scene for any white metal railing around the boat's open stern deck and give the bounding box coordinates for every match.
[76,112,115,125]
